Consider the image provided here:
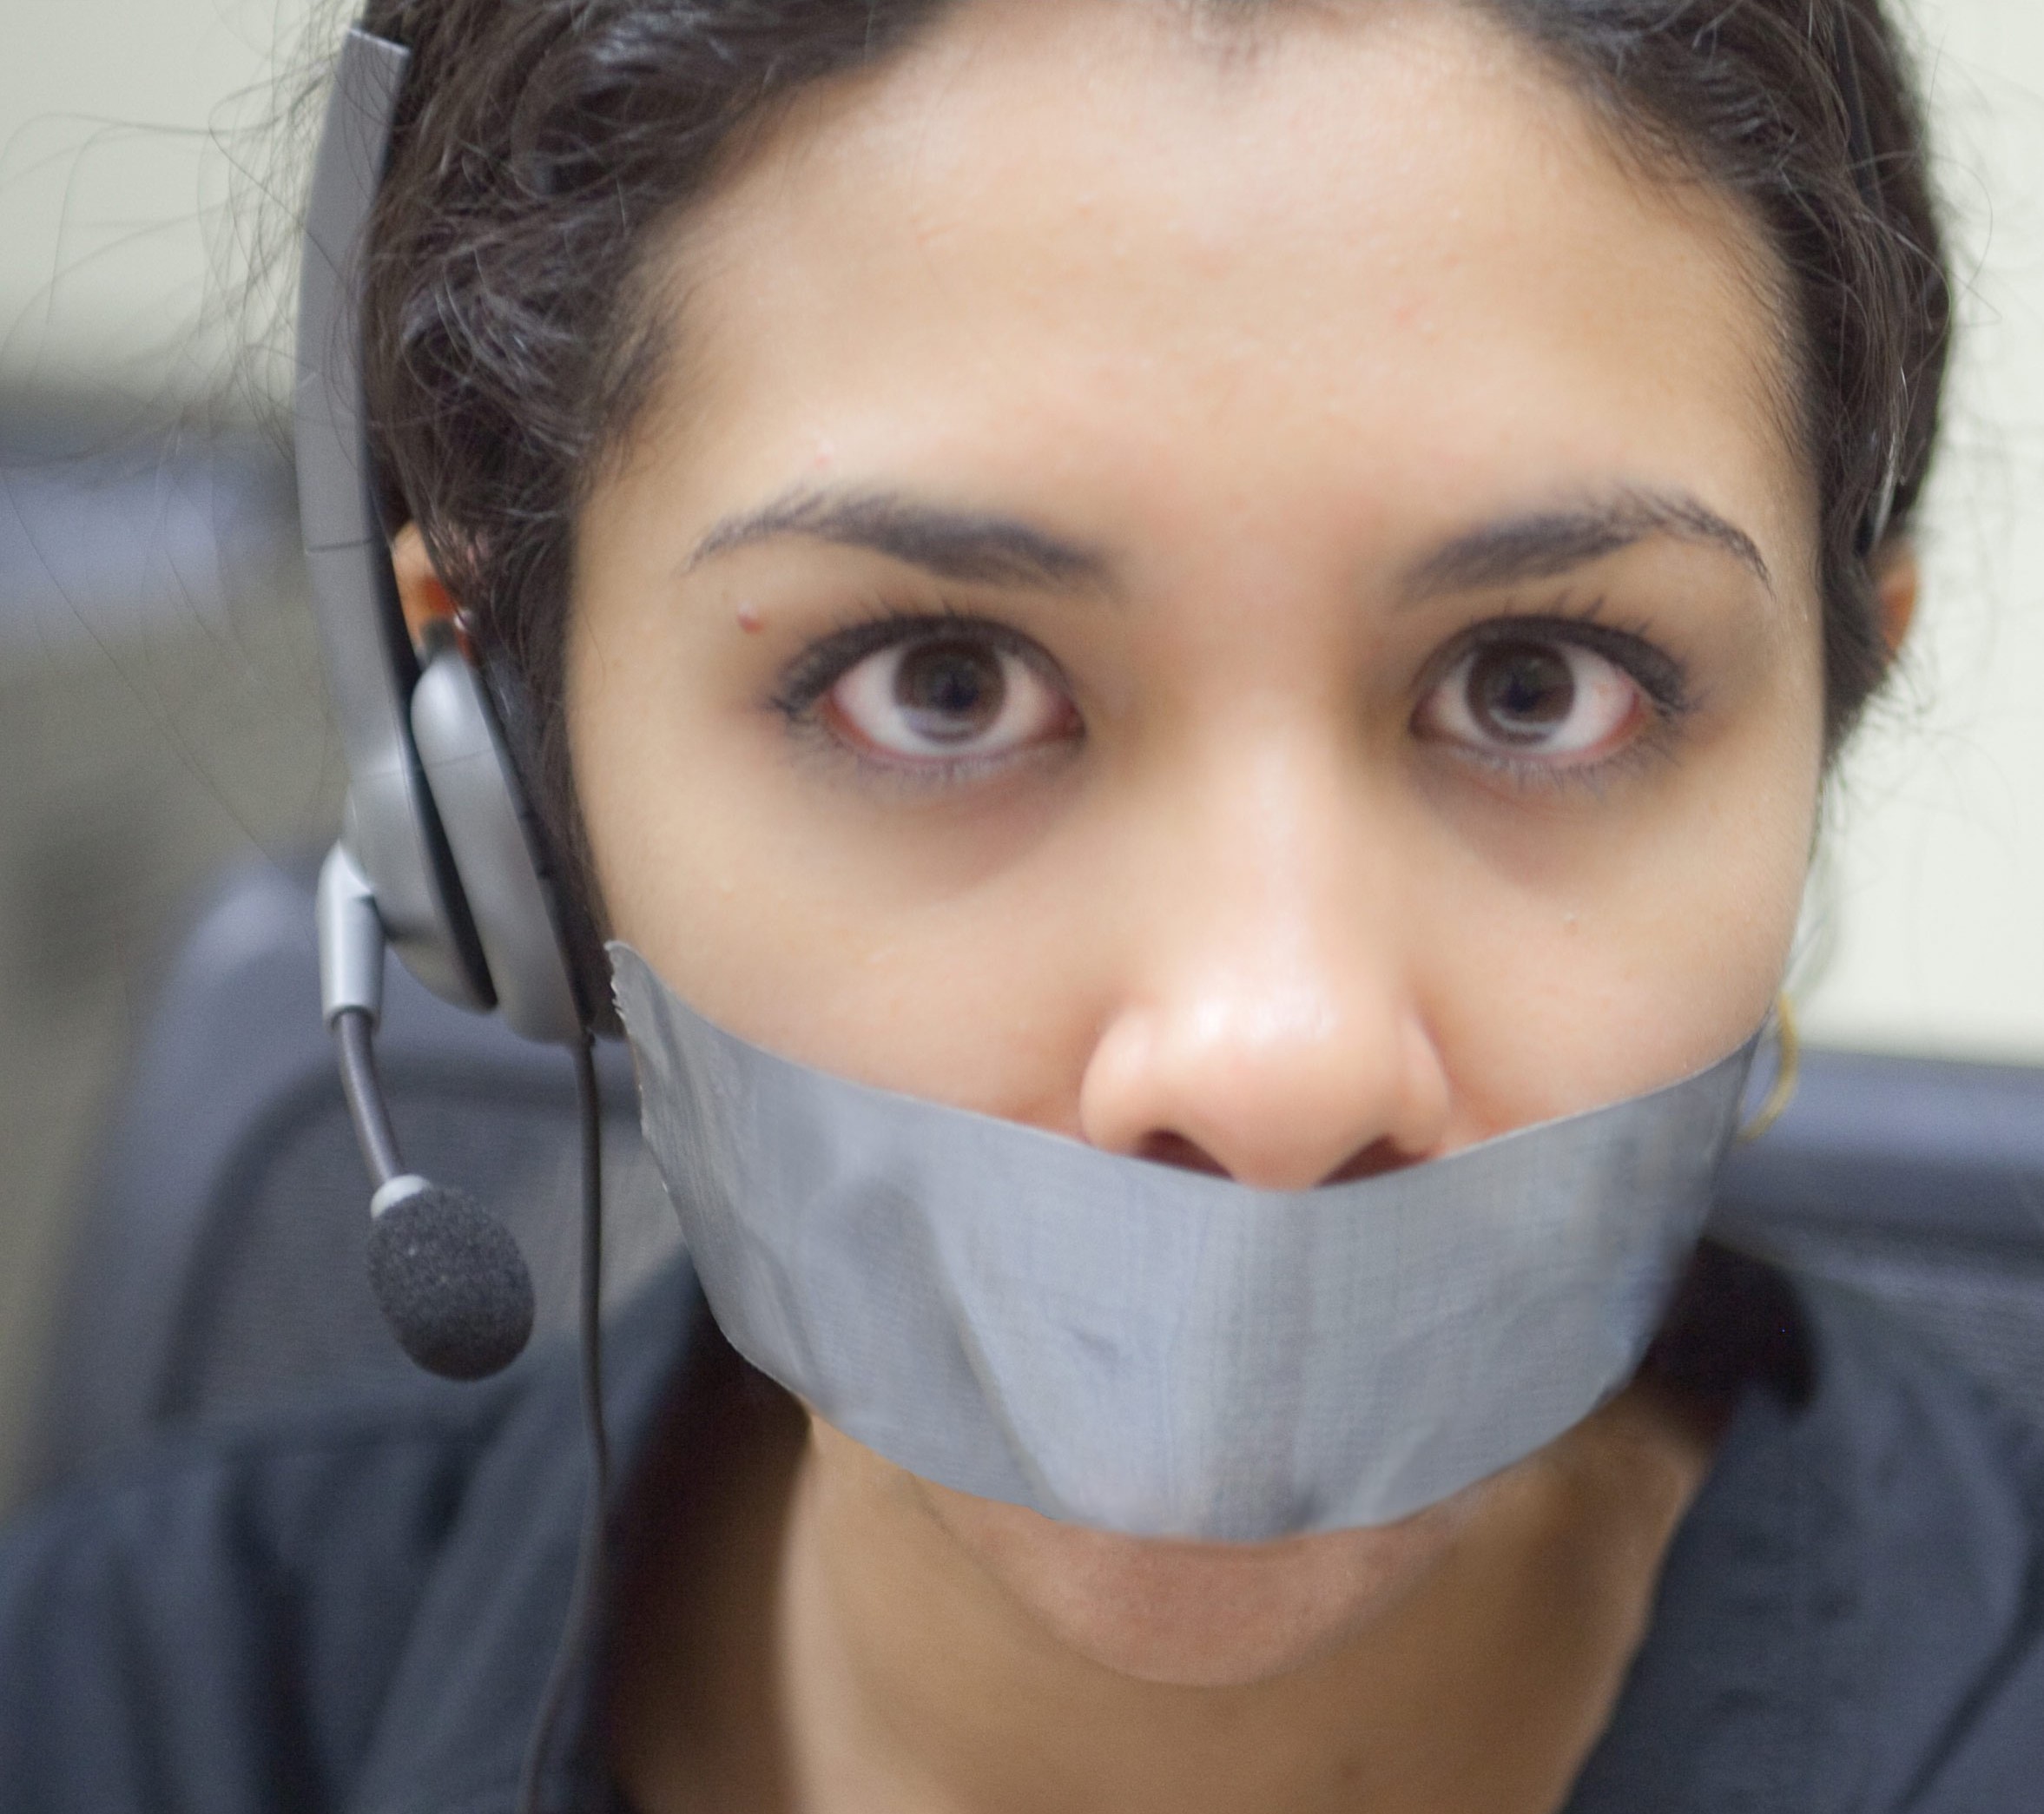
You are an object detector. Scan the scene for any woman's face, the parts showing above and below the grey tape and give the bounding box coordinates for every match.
[570,0,1821,1679]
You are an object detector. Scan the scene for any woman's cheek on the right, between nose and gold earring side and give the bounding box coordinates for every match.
[1419,637,1821,1139]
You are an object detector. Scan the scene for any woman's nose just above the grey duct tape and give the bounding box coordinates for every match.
[1079,740,1449,1191]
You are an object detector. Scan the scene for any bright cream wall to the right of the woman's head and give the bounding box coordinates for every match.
[1803,0,2044,1061]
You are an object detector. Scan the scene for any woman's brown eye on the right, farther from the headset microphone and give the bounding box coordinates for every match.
[1414,636,1650,767]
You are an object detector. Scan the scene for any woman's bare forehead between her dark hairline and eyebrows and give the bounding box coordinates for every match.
[644,0,1809,564]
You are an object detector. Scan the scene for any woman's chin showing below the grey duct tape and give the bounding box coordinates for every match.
[918,1481,1480,1687]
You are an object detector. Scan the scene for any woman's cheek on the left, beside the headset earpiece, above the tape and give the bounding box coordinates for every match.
[570,580,1098,1131]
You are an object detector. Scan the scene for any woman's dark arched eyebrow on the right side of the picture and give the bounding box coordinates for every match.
[1402,491,1774,605]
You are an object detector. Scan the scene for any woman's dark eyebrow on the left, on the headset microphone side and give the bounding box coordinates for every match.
[689,491,1112,591]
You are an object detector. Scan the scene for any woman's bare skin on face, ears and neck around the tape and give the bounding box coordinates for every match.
[397,0,1913,1814]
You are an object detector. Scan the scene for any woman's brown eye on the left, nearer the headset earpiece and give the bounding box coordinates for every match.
[824,632,1078,762]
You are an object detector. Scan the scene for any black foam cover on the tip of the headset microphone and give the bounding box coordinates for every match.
[370,1184,533,1381]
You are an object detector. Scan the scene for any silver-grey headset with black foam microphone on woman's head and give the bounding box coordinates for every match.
[296,29,601,1381]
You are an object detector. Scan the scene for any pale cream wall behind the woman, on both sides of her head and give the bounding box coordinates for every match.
[0,0,2044,1064]
